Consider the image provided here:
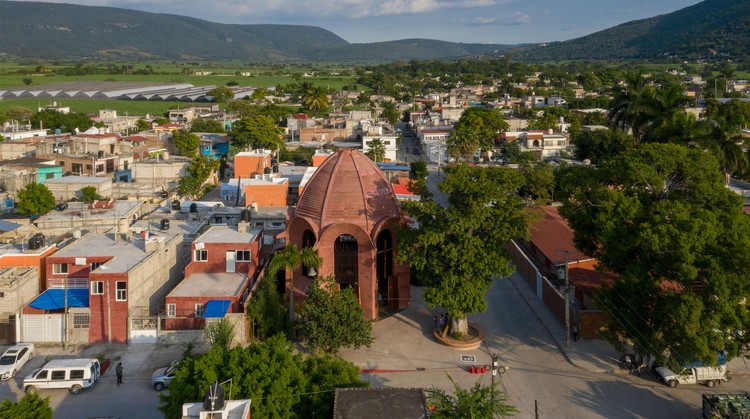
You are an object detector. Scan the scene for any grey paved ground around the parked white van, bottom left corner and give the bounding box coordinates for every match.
[0,345,191,419]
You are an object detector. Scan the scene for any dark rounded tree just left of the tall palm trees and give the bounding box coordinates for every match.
[573,129,635,164]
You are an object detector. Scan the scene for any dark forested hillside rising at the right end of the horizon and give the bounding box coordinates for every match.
[511,0,750,61]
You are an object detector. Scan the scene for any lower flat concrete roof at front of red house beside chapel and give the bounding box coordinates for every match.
[167,272,249,297]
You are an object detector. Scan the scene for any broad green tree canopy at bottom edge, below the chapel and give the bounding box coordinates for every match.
[159,335,367,419]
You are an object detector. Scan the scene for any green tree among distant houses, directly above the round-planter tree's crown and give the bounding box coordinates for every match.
[447,106,508,158]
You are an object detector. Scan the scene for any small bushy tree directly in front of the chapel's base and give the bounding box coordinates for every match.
[300,277,373,354]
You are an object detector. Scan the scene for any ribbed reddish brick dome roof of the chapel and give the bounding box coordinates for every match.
[294,149,401,233]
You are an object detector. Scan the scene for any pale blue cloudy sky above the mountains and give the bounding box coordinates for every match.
[13,0,700,44]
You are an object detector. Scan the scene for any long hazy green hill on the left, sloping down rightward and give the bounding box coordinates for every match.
[0,1,507,62]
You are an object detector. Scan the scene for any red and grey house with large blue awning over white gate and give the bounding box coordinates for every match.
[21,219,183,344]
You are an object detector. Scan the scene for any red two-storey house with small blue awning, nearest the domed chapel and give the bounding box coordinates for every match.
[166,222,264,330]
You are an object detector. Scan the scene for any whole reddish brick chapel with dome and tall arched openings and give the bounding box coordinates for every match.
[286,149,410,319]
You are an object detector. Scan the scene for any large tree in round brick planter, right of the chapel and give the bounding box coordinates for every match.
[397,164,530,335]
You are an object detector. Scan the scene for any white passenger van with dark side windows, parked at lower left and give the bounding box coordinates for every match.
[23,359,101,394]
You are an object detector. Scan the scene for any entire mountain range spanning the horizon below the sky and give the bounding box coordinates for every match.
[0,0,750,63]
